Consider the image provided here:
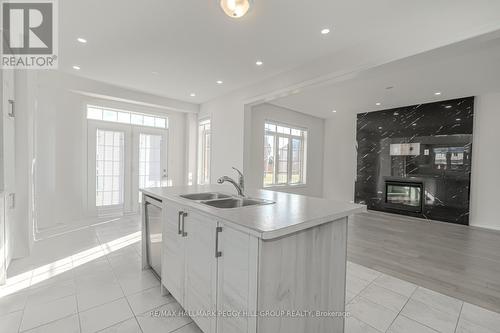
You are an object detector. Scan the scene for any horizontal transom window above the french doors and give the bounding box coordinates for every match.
[87,105,168,128]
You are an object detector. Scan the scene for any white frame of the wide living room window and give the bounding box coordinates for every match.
[262,119,309,188]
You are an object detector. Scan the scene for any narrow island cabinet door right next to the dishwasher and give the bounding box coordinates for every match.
[161,201,186,304]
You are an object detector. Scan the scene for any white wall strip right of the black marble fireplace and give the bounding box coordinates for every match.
[470,93,500,230]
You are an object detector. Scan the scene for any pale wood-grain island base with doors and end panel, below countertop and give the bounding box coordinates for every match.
[162,200,347,333]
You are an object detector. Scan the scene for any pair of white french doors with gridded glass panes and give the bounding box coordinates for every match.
[88,120,168,216]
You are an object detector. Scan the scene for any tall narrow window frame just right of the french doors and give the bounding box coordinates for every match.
[196,117,212,185]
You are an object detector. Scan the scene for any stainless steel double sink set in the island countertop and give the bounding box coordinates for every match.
[181,192,274,209]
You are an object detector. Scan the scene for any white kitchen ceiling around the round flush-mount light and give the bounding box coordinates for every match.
[59,0,500,103]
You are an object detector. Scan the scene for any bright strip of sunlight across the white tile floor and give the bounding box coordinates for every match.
[0,231,141,298]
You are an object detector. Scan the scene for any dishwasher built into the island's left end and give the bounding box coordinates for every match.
[144,196,162,279]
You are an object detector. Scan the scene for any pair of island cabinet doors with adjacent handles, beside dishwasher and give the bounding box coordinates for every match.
[162,201,217,333]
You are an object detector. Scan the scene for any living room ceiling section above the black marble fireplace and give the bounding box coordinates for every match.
[271,31,500,118]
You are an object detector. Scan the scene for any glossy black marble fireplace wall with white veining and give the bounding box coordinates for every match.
[355,97,474,225]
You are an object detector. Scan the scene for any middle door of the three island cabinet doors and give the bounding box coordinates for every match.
[184,212,217,333]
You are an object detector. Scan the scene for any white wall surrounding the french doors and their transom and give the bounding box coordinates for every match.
[35,71,197,229]
